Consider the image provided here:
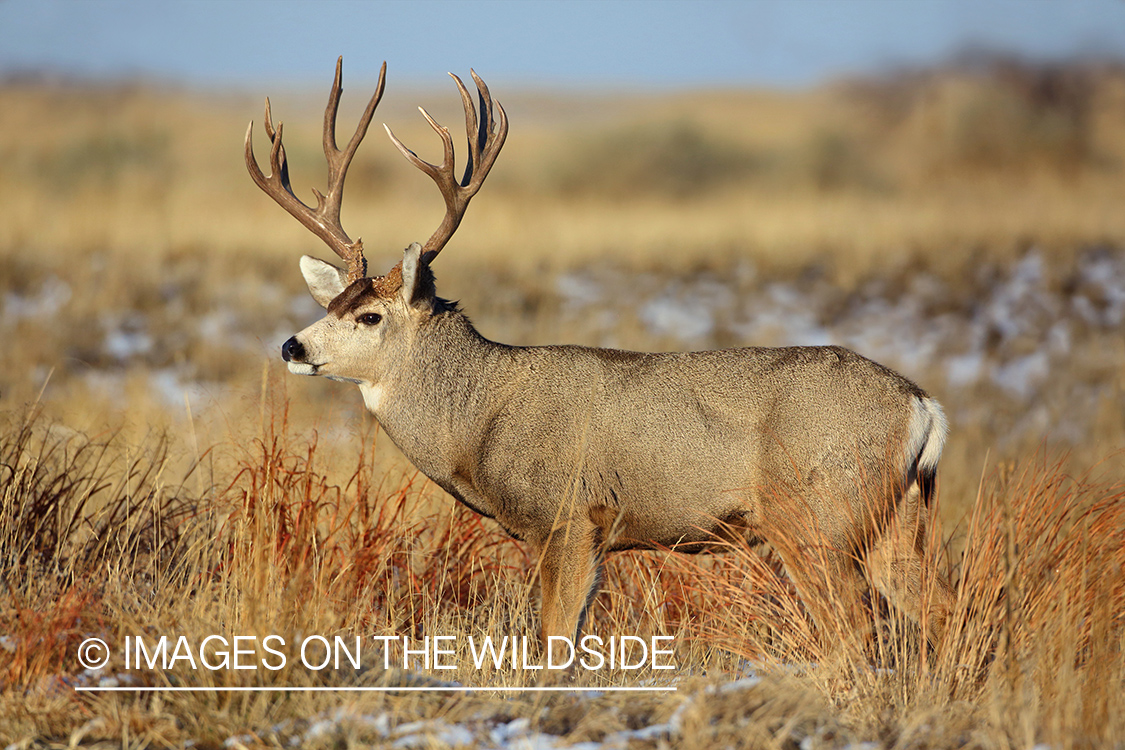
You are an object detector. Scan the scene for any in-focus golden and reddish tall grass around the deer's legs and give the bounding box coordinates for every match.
[0,397,1125,747]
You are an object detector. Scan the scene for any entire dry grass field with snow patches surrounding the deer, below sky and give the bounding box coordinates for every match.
[0,61,1125,749]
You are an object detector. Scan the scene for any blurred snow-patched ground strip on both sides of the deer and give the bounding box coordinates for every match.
[0,247,1125,443]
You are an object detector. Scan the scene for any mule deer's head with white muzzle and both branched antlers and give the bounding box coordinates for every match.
[245,57,507,391]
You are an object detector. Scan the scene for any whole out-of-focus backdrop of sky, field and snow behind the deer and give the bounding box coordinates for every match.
[0,0,1125,517]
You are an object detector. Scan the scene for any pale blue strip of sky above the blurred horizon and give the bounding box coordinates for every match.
[0,0,1125,88]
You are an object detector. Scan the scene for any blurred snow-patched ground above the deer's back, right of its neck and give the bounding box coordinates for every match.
[555,247,1125,434]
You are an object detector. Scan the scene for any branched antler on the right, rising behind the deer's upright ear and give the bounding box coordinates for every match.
[383,70,507,263]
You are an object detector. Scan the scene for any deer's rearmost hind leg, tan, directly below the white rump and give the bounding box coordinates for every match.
[864,481,953,647]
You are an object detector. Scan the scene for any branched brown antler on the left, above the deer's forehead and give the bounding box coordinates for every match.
[246,57,387,283]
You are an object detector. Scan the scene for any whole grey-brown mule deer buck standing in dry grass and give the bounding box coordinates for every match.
[245,61,952,644]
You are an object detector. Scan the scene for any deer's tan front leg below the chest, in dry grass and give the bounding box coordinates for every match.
[539,517,602,653]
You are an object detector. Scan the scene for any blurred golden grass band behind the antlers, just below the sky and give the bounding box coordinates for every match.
[0,62,1125,275]
